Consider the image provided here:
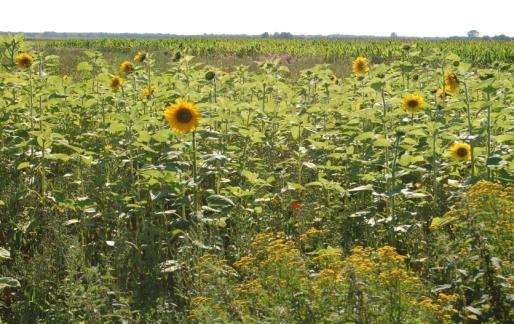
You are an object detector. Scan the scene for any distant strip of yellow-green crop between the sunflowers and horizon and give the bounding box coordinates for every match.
[30,38,514,65]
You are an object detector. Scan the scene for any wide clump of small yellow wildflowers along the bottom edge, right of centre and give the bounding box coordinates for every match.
[189,233,448,322]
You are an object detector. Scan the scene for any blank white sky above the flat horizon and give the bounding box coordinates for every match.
[0,0,514,36]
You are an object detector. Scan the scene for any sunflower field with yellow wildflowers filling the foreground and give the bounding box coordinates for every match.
[0,36,514,323]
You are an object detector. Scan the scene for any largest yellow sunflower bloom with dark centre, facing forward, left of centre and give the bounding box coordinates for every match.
[164,100,202,133]
